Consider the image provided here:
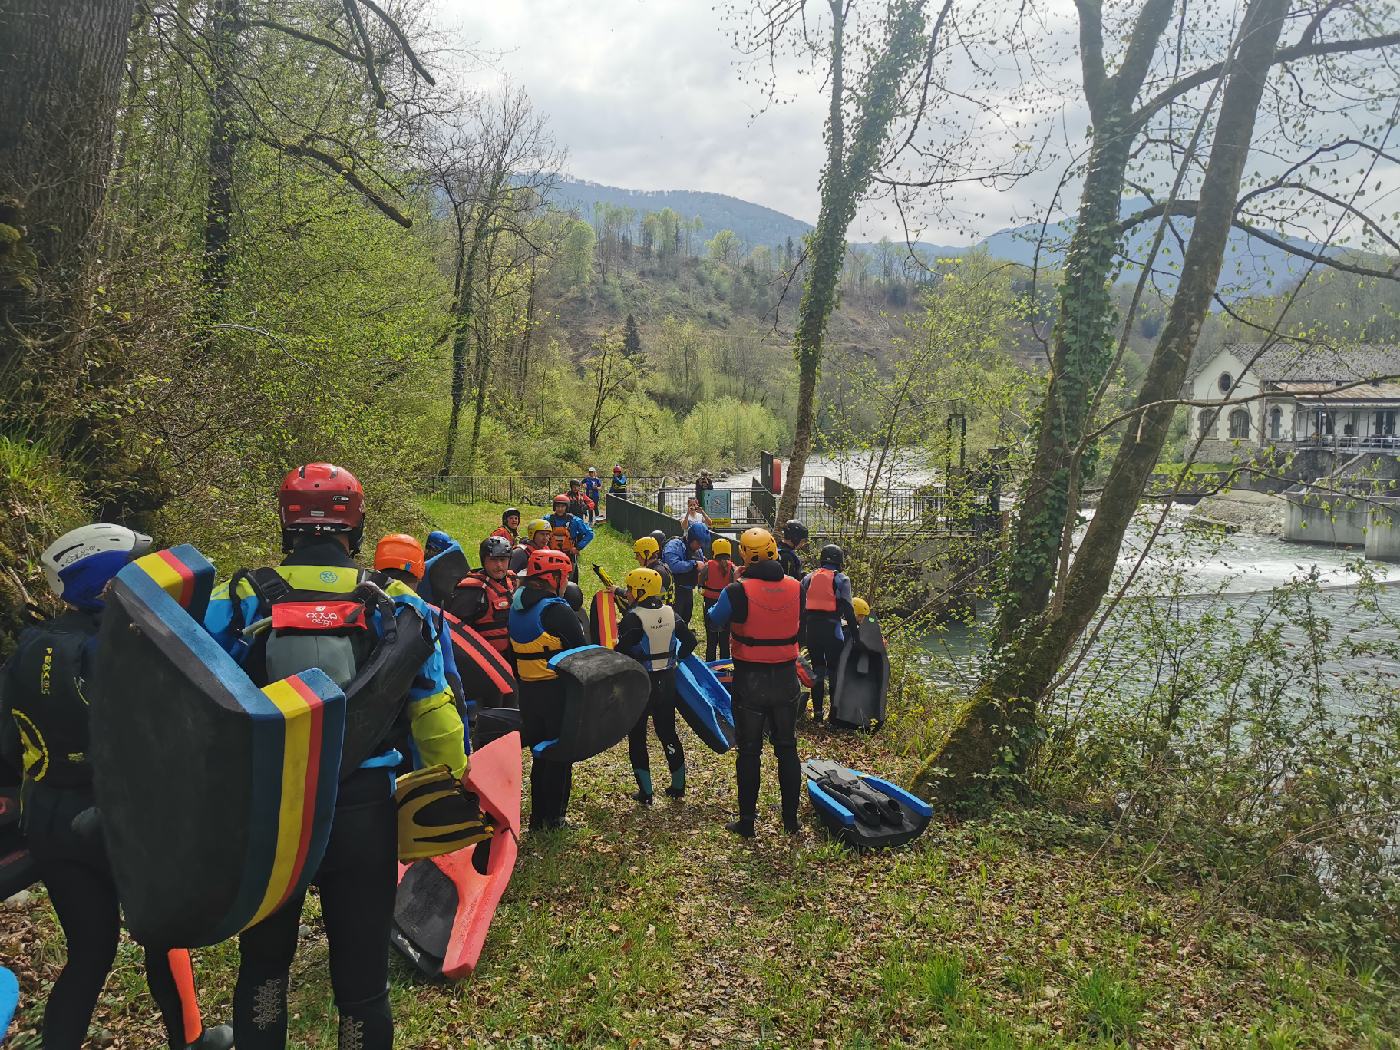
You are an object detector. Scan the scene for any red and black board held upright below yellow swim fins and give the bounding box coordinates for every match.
[393,732,521,979]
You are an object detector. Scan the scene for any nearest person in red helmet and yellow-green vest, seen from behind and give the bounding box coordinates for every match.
[204,463,468,1050]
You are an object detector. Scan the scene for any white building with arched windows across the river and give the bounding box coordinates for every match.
[1183,343,1400,462]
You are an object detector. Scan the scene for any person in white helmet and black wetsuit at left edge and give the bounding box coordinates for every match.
[0,522,232,1050]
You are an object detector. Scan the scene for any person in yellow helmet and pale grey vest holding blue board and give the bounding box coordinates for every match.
[615,568,697,806]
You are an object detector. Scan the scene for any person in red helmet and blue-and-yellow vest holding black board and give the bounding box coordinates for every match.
[510,549,588,832]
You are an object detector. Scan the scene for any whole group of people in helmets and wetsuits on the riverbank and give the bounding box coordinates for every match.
[0,463,873,1050]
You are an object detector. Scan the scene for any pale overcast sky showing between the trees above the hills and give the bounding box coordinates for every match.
[430,0,1400,252]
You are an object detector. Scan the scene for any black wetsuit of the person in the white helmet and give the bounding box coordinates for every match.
[0,610,197,1050]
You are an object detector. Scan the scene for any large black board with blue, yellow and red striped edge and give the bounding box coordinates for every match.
[91,545,346,948]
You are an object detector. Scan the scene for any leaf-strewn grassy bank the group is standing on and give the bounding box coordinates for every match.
[0,505,1400,1050]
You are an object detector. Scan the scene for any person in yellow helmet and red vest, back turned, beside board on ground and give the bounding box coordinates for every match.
[706,528,802,839]
